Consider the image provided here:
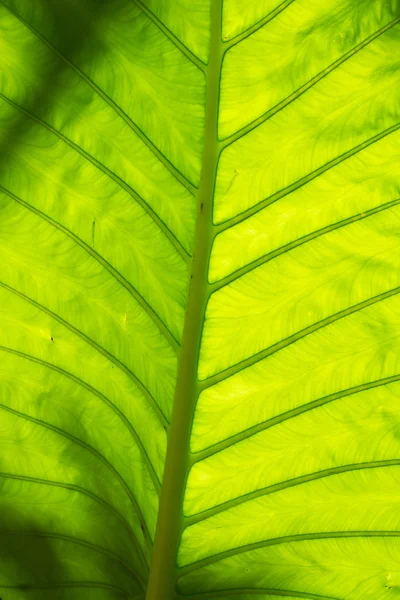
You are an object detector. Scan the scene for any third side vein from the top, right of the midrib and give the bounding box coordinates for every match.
[215,123,400,233]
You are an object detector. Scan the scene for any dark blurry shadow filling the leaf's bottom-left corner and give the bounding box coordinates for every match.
[0,504,142,600]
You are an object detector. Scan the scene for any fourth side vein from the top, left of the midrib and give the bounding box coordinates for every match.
[0,185,179,364]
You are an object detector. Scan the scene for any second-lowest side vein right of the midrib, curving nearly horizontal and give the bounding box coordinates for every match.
[180,530,400,576]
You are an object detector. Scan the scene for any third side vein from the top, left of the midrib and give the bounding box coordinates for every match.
[0,92,191,263]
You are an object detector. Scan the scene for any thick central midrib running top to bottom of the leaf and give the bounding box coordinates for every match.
[146,0,223,600]
